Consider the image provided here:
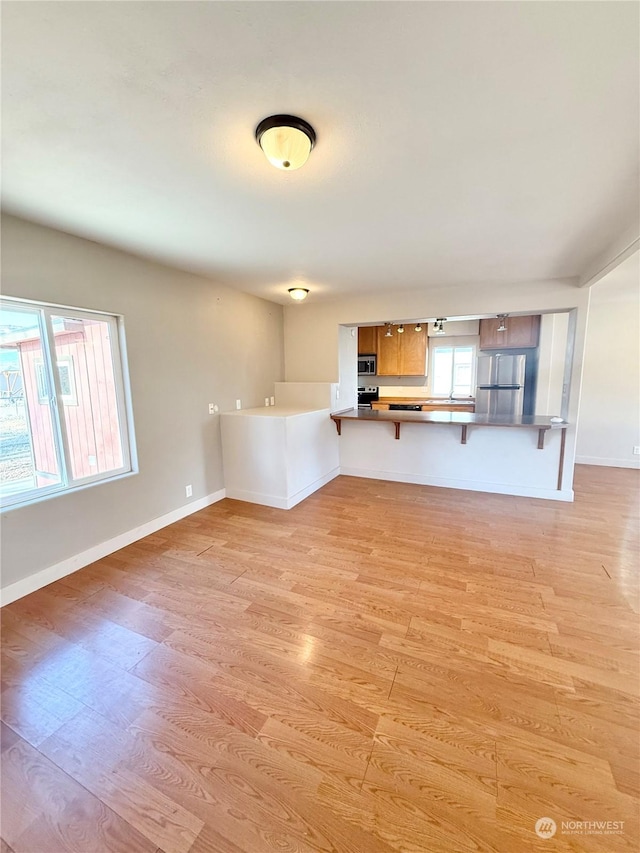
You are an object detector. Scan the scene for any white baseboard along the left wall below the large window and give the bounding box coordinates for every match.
[0,489,225,607]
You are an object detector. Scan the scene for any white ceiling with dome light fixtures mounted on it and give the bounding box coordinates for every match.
[2,0,639,301]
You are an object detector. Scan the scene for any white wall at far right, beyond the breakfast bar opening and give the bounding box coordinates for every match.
[576,253,640,468]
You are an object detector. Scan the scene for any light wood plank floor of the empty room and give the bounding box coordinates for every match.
[1,467,639,853]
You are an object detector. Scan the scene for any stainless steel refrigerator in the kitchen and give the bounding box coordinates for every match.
[476,353,527,417]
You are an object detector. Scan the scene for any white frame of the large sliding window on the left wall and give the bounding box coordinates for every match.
[0,296,137,510]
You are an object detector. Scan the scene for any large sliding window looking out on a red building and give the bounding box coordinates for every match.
[0,298,132,506]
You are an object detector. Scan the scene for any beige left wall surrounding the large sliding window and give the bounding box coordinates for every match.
[2,216,283,587]
